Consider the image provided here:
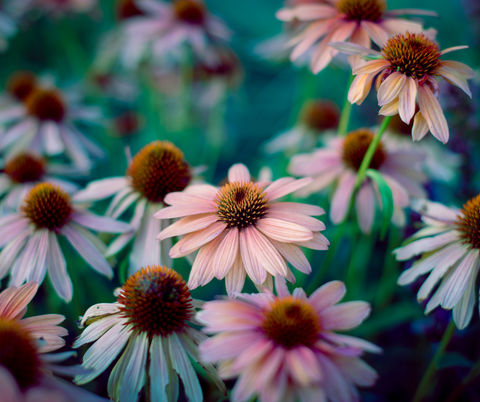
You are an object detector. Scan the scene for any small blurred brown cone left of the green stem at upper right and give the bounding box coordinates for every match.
[301,100,340,131]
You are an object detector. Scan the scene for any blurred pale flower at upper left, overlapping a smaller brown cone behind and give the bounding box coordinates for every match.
[0,86,104,170]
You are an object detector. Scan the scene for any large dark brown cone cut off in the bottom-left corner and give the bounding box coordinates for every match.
[0,317,41,392]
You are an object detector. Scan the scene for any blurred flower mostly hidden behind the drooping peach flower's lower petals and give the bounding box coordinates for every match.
[382,114,463,183]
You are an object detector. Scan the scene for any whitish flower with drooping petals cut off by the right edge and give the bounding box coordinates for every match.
[394,195,480,329]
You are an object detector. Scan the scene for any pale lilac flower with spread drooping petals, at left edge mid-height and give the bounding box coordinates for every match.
[0,183,130,301]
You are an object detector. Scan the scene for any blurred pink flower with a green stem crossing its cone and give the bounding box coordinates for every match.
[289,129,426,233]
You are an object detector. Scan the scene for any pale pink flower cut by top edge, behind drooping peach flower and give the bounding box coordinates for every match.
[277,0,436,74]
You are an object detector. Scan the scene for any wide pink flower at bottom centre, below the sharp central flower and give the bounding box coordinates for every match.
[197,278,381,402]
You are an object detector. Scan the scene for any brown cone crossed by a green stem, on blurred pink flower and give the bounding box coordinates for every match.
[342,128,387,171]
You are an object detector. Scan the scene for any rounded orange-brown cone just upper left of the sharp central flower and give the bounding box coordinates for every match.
[127,141,192,202]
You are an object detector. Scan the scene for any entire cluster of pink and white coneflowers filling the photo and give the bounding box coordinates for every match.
[0,0,480,402]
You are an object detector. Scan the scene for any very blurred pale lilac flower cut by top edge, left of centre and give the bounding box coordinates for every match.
[122,0,230,67]
